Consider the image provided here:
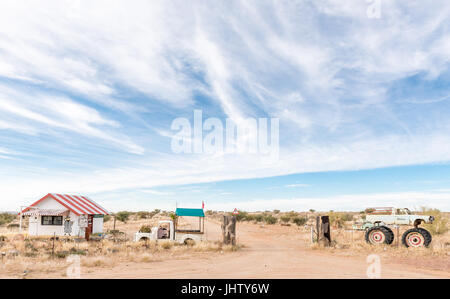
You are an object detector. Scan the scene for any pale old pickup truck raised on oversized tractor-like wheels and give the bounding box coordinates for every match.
[361,207,434,247]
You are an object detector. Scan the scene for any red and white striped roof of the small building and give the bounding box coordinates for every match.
[22,193,109,216]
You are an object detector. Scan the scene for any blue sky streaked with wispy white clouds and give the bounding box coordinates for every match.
[0,0,450,211]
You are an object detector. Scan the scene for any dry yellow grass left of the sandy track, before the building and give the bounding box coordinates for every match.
[0,217,237,278]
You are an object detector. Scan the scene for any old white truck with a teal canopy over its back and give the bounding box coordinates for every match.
[134,208,205,245]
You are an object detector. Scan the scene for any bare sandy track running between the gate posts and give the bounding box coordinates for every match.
[82,220,450,278]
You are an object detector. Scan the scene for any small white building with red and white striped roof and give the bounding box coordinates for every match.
[20,193,109,239]
